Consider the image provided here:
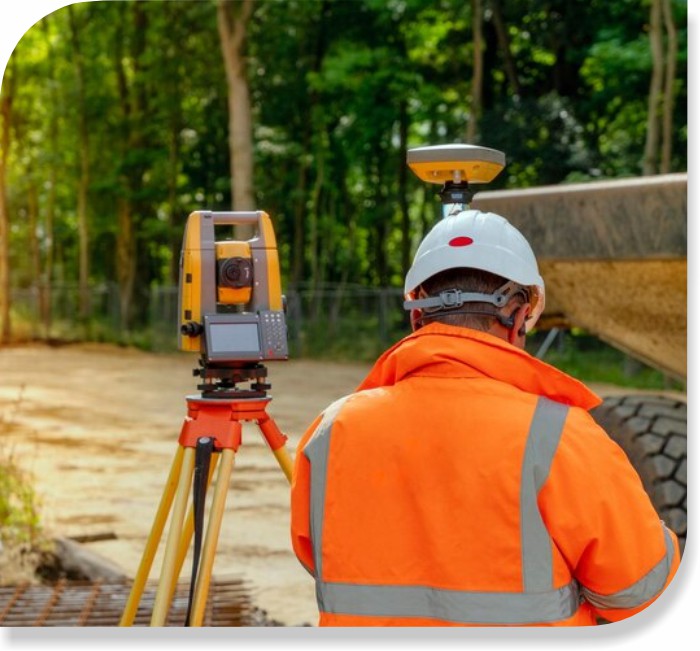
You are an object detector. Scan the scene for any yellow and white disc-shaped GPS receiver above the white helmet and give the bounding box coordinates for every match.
[406,144,506,184]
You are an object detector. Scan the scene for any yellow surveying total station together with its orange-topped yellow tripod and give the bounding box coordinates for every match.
[120,211,292,626]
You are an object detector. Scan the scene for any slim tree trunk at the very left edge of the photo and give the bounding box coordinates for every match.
[0,57,15,344]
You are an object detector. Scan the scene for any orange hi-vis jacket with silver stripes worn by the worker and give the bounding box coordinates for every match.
[291,324,679,626]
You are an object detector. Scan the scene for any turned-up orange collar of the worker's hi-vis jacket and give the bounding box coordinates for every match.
[357,323,602,410]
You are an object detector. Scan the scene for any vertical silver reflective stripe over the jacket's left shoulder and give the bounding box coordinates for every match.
[304,396,350,580]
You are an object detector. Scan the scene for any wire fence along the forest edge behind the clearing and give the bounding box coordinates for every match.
[5,283,677,388]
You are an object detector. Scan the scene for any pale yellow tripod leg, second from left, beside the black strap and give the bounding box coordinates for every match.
[151,448,194,626]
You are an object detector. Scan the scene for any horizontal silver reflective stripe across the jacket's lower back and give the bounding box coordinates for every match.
[317,582,579,624]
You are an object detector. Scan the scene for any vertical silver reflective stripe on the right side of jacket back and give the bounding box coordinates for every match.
[520,397,569,593]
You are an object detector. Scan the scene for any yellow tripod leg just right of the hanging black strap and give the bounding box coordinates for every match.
[190,448,235,626]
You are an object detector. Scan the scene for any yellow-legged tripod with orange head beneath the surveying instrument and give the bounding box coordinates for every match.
[119,372,292,626]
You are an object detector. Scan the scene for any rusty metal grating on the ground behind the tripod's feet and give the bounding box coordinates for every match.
[0,578,265,626]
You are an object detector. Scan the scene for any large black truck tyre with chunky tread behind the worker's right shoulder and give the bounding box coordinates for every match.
[591,396,688,554]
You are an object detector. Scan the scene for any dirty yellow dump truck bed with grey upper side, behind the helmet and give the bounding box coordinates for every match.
[472,174,688,380]
